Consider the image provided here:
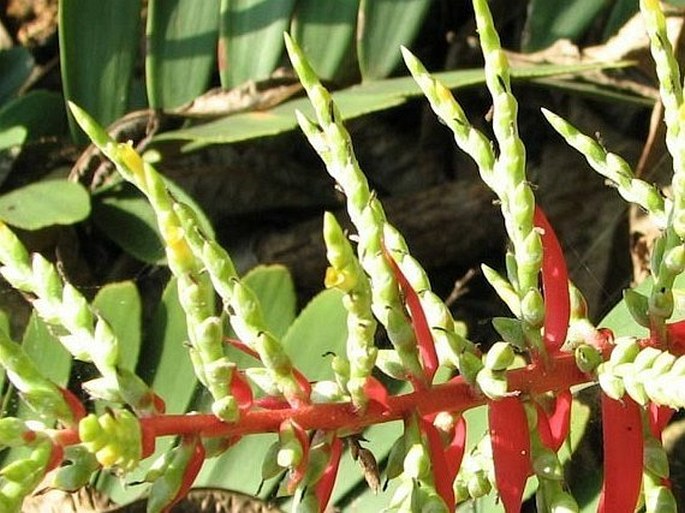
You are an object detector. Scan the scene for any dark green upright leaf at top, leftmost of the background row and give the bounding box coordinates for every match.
[59,0,141,142]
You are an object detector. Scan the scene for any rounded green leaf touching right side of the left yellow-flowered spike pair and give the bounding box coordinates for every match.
[243,265,297,338]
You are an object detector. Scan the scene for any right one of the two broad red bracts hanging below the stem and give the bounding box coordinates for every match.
[597,394,644,513]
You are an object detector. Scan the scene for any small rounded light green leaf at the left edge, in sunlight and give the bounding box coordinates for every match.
[0,180,90,230]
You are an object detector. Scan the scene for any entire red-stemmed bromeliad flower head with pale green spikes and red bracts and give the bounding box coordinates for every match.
[0,0,685,513]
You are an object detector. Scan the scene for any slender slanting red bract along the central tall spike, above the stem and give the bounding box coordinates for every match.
[383,247,438,385]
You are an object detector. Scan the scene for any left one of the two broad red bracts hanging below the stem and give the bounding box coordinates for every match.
[488,397,531,513]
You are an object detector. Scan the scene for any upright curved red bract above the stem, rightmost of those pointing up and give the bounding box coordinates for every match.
[533,206,571,353]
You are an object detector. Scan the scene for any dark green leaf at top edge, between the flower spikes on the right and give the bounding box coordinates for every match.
[523,0,611,52]
